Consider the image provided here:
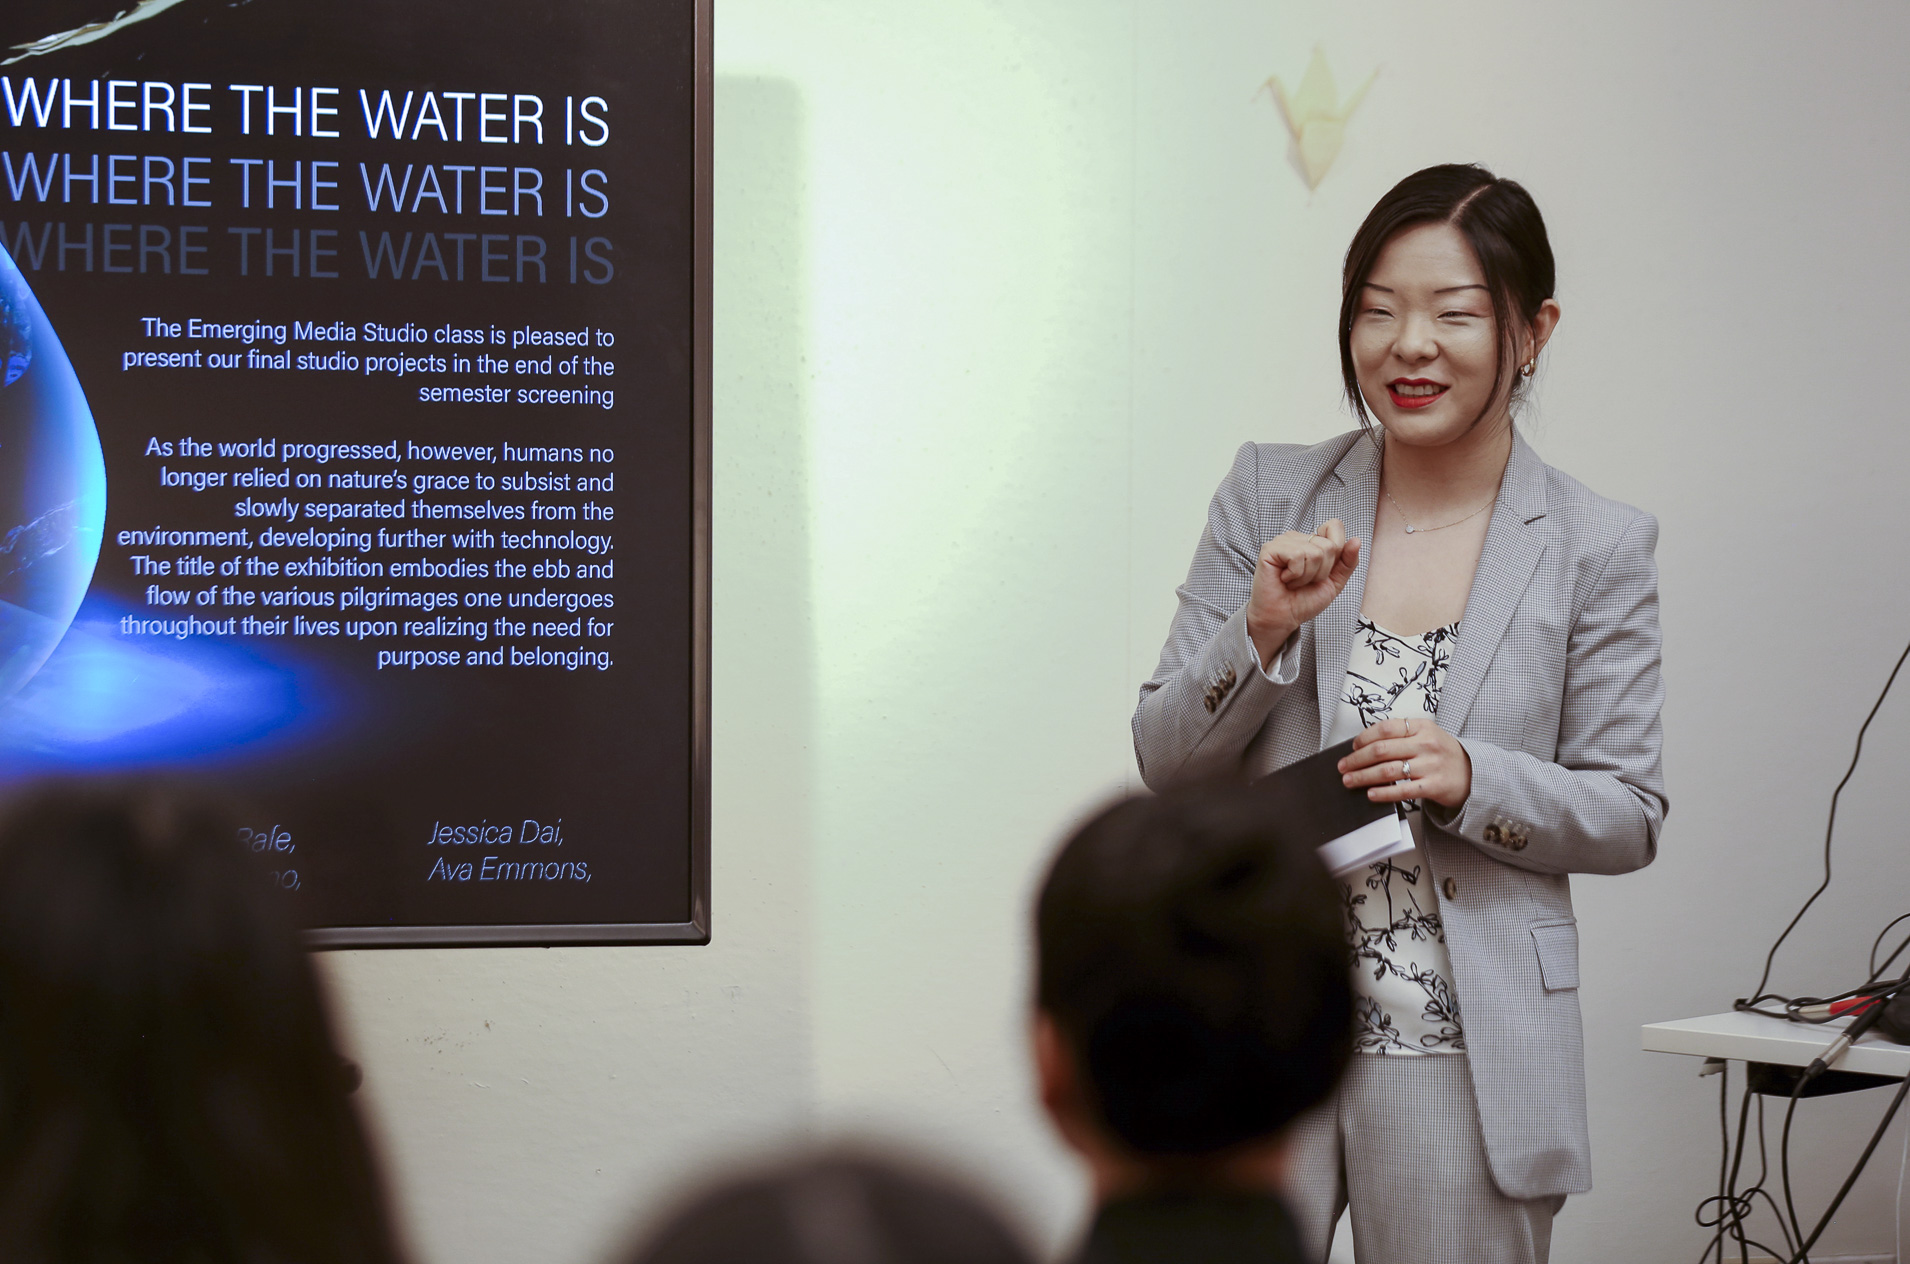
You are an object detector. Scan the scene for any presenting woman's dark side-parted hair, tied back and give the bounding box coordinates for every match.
[1339,162,1559,432]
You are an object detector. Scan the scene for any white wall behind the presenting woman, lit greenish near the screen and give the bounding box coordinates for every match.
[327,0,1910,1264]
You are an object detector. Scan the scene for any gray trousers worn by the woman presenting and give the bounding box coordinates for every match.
[1287,1054,1564,1264]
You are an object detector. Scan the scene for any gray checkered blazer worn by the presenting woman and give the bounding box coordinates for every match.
[1135,432,1666,1199]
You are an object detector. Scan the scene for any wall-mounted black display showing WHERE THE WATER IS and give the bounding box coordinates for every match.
[0,0,711,945]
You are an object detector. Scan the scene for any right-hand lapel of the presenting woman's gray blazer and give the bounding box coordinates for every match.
[1438,432,1545,733]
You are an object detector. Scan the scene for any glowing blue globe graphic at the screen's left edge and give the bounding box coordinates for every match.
[0,246,107,701]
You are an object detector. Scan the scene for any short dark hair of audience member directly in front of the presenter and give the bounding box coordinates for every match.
[1035,787,1352,1157]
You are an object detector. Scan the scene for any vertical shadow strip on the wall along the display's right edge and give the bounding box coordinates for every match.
[711,76,816,947]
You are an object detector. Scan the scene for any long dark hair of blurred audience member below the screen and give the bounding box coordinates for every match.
[0,785,397,1264]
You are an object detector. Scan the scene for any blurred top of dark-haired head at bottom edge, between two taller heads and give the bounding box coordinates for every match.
[630,1155,1031,1264]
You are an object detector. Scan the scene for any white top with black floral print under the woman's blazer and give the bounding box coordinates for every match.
[1327,617,1465,1056]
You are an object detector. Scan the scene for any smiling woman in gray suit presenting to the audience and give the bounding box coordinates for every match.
[1135,166,1666,1264]
